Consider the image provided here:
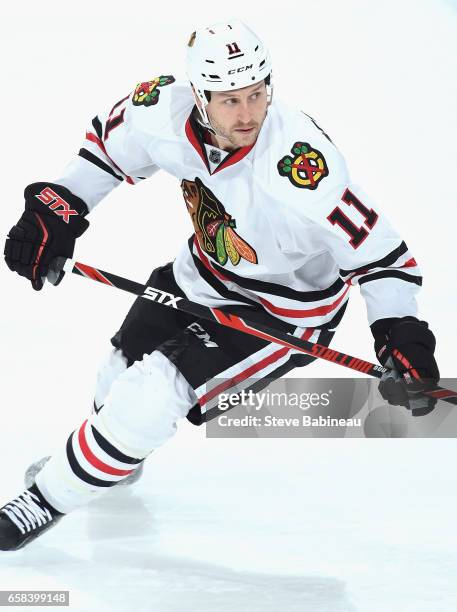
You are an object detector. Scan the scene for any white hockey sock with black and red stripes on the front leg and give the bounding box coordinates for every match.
[36,351,196,513]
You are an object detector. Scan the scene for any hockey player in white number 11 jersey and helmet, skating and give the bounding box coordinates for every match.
[0,21,439,550]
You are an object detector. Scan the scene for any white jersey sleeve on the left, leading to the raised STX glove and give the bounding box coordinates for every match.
[55,86,159,210]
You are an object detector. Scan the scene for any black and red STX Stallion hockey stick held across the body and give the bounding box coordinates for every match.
[59,259,457,405]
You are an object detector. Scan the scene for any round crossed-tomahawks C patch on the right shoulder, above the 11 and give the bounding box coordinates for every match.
[278,142,328,189]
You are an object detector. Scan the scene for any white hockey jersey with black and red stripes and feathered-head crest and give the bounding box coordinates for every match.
[56,75,421,329]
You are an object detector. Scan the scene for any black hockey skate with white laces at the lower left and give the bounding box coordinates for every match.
[0,485,63,550]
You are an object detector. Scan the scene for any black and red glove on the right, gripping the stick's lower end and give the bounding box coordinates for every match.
[371,317,440,416]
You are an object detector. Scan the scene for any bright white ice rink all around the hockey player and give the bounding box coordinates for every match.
[0,0,457,612]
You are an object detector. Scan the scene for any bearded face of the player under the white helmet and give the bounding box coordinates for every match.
[206,81,267,150]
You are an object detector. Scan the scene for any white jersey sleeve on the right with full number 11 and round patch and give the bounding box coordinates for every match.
[275,114,422,325]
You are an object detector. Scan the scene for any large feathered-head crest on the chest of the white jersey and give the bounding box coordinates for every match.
[181,177,257,266]
